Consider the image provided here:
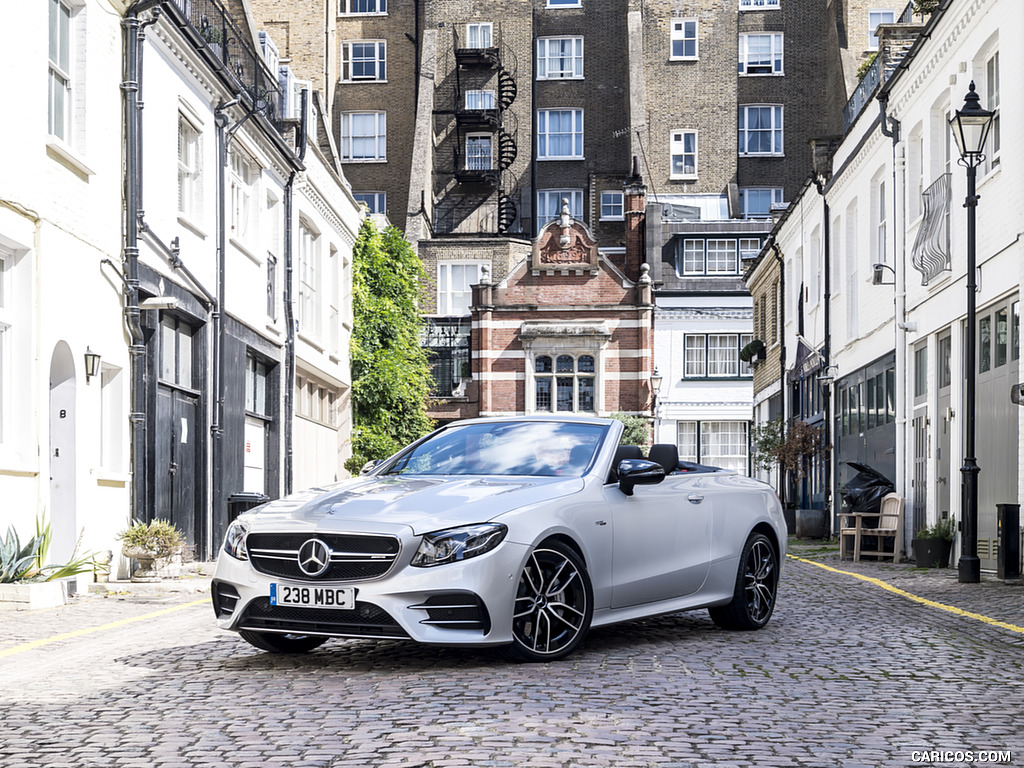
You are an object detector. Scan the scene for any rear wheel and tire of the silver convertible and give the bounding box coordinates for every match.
[708,532,778,631]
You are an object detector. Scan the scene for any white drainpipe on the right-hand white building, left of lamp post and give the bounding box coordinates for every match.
[879,97,905,512]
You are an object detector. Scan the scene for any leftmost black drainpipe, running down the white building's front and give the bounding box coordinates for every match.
[121,0,158,520]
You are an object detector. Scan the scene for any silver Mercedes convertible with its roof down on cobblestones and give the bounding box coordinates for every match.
[212,417,785,662]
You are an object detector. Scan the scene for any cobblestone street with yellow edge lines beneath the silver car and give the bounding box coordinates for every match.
[0,548,1024,768]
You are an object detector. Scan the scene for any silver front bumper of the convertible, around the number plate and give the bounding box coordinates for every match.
[211,537,529,645]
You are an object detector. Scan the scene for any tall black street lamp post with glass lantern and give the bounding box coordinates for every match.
[949,82,995,584]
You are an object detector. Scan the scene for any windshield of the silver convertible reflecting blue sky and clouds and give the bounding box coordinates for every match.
[385,421,607,477]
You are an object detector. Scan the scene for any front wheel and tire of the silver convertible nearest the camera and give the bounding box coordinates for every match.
[502,542,594,662]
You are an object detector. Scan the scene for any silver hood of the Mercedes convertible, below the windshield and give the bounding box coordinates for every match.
[238,475,584,534]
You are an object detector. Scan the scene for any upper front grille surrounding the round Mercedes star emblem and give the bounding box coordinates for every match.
[246,532,400,582]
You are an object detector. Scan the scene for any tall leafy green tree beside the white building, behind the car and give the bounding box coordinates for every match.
[345,219,433,473]
